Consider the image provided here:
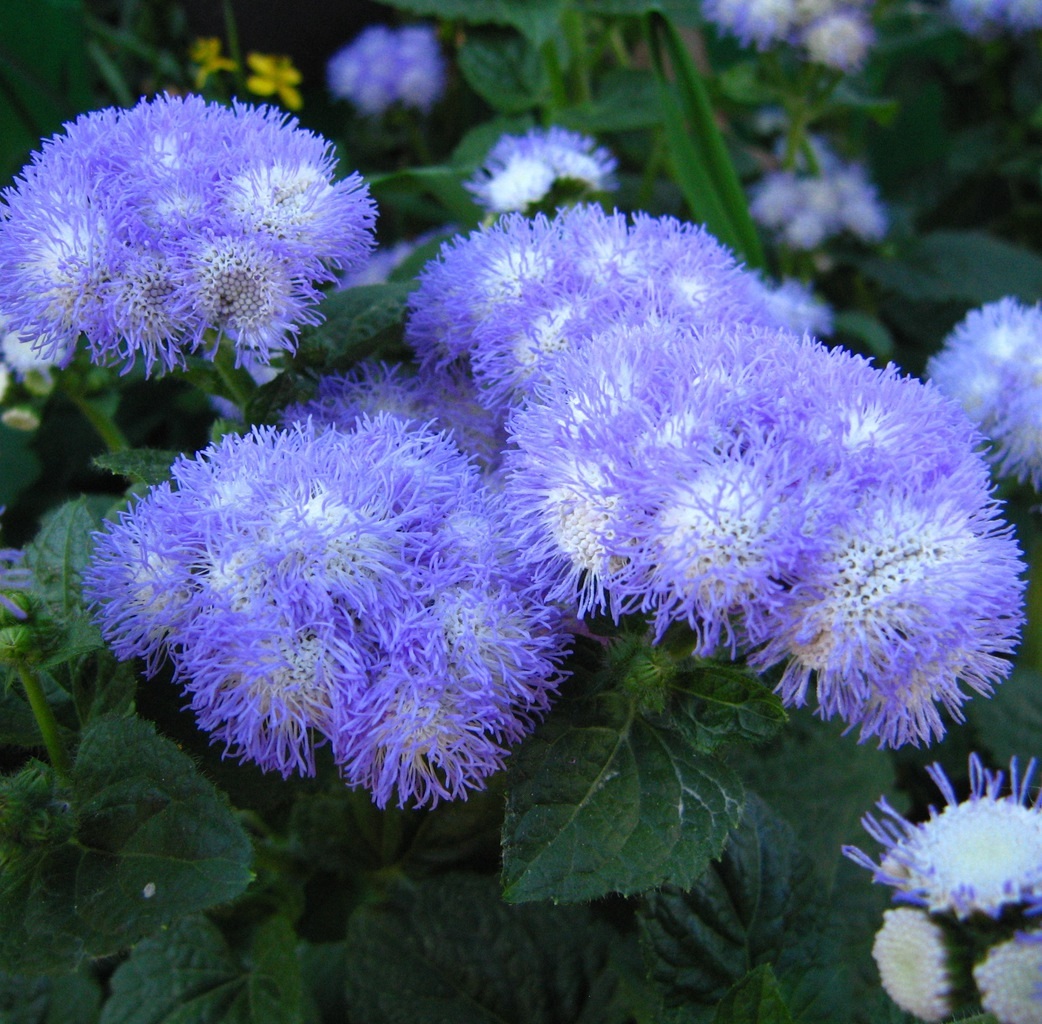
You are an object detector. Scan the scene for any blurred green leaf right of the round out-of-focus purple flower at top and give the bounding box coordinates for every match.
[456,33,547,114]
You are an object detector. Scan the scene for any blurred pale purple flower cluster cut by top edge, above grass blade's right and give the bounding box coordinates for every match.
[702,0,874,72]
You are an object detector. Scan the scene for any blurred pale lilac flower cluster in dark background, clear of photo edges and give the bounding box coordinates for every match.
[749,144,887,250]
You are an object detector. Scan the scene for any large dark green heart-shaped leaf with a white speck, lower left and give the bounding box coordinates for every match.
[0,718,251,971]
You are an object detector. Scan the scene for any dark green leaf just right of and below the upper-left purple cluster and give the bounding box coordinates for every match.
[298,282,416,366]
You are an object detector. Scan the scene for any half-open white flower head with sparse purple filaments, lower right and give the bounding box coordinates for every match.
[843,754,1042,920]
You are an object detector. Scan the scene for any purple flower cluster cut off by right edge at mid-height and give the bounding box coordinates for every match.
[926,297,1042,491]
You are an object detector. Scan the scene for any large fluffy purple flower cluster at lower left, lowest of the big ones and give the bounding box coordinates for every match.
[85,415,564,806]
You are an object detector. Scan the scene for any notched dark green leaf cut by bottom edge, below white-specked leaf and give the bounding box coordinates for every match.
[100,916,303,1024]
